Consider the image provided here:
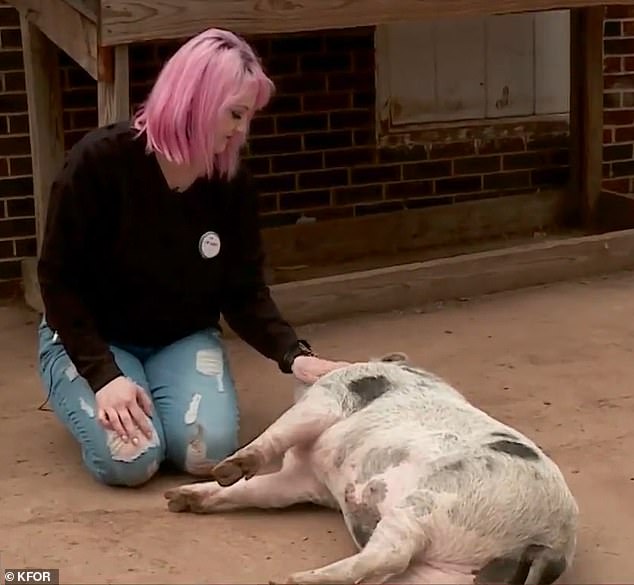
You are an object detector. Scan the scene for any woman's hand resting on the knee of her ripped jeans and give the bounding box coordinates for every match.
[95,376,152,444]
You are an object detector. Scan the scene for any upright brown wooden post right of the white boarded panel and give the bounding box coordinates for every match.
[570,6,605,227]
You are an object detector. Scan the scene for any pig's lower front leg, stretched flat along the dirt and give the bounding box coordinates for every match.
[165,449,336,514]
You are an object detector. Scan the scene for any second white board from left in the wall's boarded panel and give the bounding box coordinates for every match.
[430,18,486,121]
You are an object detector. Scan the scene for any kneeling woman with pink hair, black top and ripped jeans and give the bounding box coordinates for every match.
[38,29,343,486]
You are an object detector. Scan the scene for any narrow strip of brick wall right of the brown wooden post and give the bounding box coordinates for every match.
[603,6,634,193]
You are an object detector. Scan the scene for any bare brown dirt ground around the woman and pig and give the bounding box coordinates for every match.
[0,274,634,584]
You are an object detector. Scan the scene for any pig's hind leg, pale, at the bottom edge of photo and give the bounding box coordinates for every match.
[276,512,426,585]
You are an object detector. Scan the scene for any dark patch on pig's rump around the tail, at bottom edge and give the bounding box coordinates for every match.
[473,544,566,585]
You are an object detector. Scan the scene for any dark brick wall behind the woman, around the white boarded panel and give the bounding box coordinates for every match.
[0,4,616,296]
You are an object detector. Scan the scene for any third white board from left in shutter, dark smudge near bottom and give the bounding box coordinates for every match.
[486,14,534,118]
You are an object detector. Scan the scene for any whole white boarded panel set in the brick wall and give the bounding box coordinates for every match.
[376,10,570,126]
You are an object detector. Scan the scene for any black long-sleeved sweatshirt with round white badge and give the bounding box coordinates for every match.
[38,122,297,392]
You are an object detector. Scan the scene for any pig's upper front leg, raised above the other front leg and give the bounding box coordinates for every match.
[212,382,344,486]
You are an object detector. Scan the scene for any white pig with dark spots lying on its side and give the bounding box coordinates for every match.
[165,354,579,585]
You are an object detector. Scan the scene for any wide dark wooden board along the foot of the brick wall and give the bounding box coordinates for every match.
[262,190,567,271]
